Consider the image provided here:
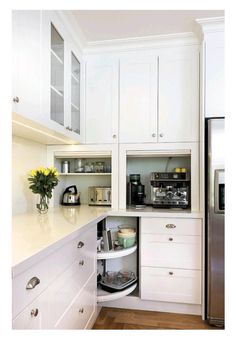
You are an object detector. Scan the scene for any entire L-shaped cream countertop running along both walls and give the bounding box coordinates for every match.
[12,205,202,270]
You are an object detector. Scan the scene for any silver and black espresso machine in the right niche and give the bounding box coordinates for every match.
[151,172,190,209]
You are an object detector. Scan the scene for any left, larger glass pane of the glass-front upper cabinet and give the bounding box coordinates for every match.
[50,23,65,125]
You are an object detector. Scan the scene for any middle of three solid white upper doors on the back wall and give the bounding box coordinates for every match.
[119,53,158,143]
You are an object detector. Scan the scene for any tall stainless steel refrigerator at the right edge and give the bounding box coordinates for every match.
[206,118,225,326]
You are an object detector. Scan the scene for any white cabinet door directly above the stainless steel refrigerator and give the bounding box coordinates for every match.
[205,32,225,117]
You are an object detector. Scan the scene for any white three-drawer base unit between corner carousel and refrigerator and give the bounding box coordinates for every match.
[140,217,202,304]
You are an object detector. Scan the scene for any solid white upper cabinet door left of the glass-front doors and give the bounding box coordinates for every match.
[12,10,41,120]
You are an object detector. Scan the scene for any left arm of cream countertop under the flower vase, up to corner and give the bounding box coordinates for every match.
[12,205,111,267]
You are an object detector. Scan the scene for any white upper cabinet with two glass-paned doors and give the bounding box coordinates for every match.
[42,11,82,141]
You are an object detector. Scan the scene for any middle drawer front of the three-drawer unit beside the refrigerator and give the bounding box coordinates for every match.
[141,234,201,269]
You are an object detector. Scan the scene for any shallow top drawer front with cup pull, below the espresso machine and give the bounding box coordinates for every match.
[141,217,201,236]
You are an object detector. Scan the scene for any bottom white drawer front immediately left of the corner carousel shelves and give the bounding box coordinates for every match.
[55,274,96,329]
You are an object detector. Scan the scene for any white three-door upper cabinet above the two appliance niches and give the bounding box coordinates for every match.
[86,46,199,143]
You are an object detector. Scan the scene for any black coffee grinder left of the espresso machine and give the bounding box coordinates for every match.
[127,174,146,208]
